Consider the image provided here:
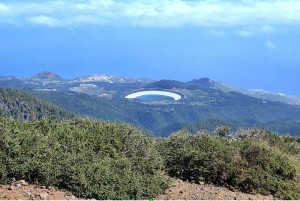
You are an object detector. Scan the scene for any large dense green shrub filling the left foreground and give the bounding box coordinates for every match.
[0,118,167,199]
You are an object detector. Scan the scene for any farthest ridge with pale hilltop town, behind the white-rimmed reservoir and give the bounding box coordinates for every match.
[0,71,300,105]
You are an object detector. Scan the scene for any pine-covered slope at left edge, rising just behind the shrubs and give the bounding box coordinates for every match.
[0,87,75,120]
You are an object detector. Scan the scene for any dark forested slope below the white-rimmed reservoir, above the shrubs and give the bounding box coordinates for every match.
[32,91,300,136]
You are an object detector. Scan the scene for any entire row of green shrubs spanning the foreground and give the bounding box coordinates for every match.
[0,117,300,199]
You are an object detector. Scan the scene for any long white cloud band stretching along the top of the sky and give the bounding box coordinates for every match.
[0,0,300,27]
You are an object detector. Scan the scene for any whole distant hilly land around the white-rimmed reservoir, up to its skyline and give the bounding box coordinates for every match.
[0,72,300,136]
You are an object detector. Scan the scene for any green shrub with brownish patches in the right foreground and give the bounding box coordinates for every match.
[160,129,300,199]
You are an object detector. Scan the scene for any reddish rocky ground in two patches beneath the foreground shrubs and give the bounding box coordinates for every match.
[0,180,275,200]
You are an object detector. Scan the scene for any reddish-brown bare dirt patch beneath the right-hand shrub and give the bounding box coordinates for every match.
[157,180,275,200]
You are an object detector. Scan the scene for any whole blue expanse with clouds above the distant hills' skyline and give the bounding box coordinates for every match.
[0,0,300,96]
